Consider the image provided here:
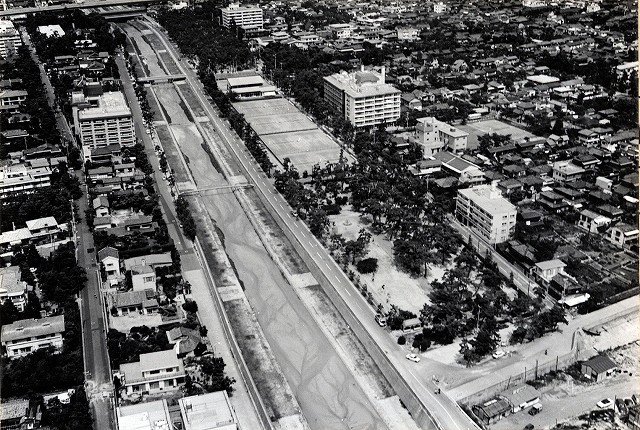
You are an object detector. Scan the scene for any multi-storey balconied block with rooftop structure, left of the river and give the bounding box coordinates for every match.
[74,91,136,161]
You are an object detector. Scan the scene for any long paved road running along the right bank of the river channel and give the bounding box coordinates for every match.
[140,15,476,430]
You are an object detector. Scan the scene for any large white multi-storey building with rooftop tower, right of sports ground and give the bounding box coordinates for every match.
[324,66,401,127]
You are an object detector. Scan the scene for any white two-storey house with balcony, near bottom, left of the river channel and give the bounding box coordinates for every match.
[120,349,186,395]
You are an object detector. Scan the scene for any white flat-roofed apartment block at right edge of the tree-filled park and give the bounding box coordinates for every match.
[456,185,517,244]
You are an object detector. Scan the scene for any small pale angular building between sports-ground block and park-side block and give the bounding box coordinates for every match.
[414,116,469,158]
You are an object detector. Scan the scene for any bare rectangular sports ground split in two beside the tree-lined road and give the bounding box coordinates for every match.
[233,98,346,173]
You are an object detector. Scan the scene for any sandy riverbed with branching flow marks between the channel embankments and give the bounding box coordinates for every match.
[132,21,385,429]
